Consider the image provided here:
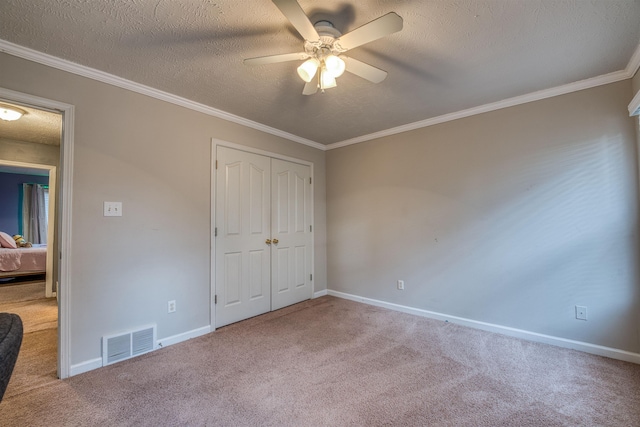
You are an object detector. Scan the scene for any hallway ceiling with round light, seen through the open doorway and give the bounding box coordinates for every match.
[0,102,62,145]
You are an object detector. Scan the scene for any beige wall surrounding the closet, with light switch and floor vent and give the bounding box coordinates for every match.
[0,54,326,365]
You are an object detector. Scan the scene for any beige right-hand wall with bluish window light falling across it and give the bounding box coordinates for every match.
[327,80,640,352]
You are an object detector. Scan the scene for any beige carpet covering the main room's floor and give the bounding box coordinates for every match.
[0,297,640,426]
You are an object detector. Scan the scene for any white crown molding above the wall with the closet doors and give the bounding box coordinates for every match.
[0,39,326,151]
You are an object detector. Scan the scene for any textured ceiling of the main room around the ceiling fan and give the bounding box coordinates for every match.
[0,0,640,144]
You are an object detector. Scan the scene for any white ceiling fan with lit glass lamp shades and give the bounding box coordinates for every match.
[244,0,402,95]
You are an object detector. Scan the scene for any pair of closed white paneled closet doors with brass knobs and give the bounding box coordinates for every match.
[213,146,313,327]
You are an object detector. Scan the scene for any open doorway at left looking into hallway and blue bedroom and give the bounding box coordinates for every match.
[0,101,63,396]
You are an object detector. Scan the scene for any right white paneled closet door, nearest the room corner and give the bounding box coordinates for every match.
[271,159,312,310]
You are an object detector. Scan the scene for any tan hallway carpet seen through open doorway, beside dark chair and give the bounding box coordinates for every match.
[0,282,58,400]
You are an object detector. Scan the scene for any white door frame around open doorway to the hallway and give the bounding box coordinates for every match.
[0,87,75,379]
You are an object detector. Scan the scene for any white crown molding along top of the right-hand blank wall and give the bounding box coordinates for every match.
[327,68,640,150]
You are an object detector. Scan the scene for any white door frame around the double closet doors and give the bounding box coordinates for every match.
[209,138,315,331]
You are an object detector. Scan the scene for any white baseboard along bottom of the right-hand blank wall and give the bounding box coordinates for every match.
[327,290,640,364]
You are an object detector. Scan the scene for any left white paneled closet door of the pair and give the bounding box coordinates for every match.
[215,147,271,327]
